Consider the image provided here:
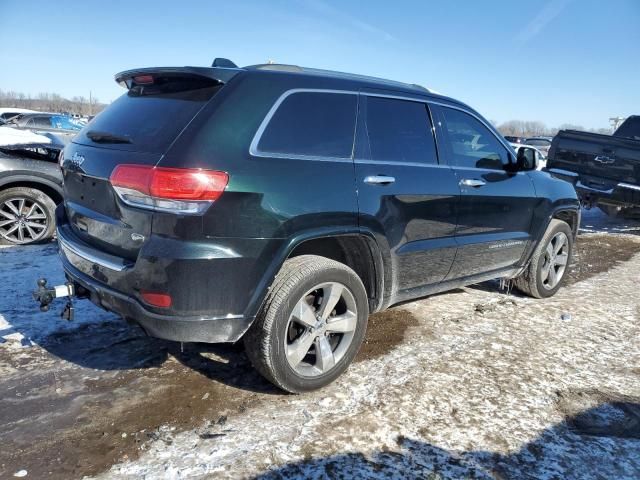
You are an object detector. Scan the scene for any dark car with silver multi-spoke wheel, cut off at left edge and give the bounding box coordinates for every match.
[0,145,62,245]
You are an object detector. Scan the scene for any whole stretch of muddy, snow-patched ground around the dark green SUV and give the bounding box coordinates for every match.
[0,212,640,479]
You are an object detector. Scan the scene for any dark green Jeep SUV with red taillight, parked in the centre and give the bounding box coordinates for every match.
[57,59,580,392]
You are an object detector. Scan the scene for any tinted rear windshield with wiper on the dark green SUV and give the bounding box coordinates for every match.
[74,82,221,153]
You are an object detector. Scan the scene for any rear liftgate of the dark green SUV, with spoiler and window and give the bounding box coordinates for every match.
[63,69,231,260]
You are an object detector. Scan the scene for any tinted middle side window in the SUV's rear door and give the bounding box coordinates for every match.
[367,97,437,163]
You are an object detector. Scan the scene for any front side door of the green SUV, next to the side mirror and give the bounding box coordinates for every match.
[437,105,537,280]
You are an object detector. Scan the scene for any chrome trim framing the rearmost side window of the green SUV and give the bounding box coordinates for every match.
[249,88,358,163]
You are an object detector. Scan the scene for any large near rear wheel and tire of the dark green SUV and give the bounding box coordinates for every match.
[244,255,369,393]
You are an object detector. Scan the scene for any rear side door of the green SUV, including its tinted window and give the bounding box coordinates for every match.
[355,93,460,301]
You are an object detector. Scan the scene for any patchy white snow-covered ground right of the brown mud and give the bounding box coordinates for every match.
[97,212,640,479]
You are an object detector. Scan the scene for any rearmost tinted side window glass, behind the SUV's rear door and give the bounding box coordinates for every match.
[258,92,358,158]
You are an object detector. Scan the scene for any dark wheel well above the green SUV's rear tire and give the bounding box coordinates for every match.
[288,235,381,312]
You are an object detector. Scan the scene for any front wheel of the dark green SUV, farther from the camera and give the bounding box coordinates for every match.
[514,218,573,298]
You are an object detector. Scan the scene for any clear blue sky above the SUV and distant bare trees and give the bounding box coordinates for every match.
[0,0,640,127]
